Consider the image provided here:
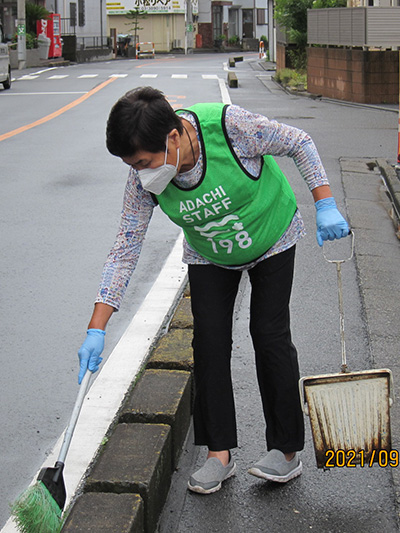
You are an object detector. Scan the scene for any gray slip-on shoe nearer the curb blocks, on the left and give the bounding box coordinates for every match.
[188,456,236,494]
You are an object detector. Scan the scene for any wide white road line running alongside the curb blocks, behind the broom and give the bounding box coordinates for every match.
[1,233,186,533]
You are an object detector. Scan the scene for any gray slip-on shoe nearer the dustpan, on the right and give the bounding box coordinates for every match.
[248,450,303,483]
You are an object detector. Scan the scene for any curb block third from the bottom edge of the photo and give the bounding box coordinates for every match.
[120,369,191,469]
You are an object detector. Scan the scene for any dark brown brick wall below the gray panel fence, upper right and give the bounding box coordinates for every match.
[307,47,399,104]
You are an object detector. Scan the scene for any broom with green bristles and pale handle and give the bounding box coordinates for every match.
[11,371,92,533]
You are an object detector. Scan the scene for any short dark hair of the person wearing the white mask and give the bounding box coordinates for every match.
[106,87,183,157]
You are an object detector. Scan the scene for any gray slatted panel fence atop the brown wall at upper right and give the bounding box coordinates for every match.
[307,7,400,48]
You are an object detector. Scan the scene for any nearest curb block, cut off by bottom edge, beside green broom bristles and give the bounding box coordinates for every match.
[62,492,144,533]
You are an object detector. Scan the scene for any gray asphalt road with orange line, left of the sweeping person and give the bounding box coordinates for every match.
[0,54,244,528]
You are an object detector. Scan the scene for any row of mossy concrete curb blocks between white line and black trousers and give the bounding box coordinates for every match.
[62,290,193,533]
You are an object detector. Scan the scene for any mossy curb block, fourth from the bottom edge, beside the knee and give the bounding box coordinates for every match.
[147,329,193,372]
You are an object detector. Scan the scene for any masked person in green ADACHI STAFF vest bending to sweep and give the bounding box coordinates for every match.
[79,87,349,494]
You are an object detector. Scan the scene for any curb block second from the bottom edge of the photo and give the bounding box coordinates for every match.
[85,424,172,533]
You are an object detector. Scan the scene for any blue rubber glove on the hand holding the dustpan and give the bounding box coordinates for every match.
[315,197,350,246]
